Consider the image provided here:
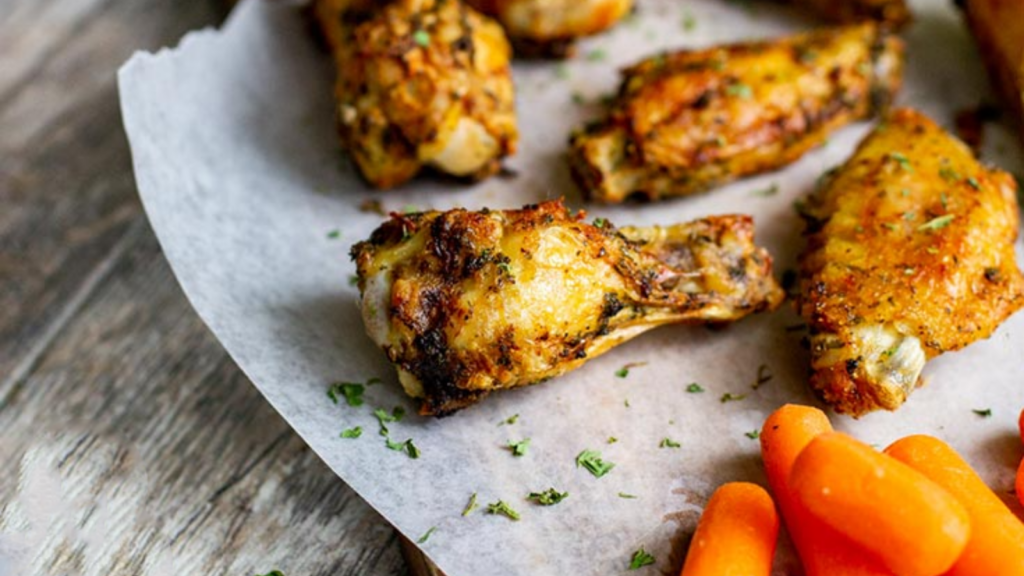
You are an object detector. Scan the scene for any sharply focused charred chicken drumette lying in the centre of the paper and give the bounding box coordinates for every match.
[352,201,782,416]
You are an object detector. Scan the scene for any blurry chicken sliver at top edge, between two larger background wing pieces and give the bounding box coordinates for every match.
[466,0,633,57]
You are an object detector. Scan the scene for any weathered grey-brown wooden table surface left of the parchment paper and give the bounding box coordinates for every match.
[0,0,432,576]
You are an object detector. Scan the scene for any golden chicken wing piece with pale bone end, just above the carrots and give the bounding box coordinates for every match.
[798,110,1024,415]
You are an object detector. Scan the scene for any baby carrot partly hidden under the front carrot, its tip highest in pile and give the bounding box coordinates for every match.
[761,404,892,576]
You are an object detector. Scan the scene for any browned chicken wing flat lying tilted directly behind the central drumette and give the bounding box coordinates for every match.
[569,24,903,203]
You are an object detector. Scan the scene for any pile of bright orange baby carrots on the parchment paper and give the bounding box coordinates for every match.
[682,405,1024,576]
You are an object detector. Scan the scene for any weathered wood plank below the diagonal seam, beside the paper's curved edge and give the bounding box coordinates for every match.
[0,223,406,576]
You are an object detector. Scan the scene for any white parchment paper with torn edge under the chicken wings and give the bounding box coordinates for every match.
[120,0,1024,576]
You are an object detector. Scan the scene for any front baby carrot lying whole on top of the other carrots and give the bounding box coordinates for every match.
[790,433,971,576]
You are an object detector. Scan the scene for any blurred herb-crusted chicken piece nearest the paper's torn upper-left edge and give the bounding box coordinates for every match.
[313,0,517,189]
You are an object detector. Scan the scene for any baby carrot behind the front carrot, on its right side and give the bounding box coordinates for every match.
[886,436,1024,576]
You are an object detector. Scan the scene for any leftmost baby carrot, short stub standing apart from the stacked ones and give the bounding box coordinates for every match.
[682,482,778,576]
